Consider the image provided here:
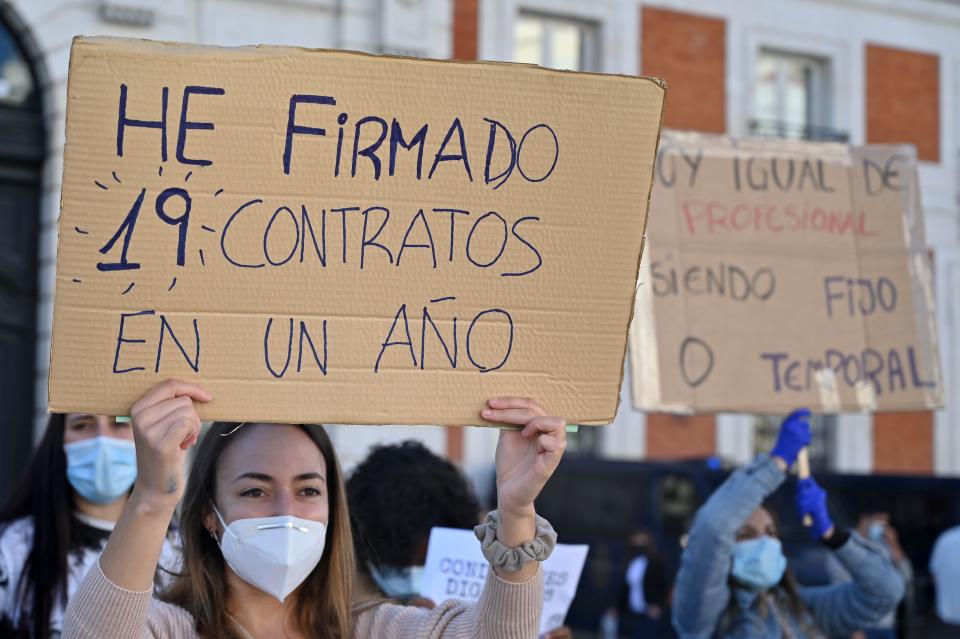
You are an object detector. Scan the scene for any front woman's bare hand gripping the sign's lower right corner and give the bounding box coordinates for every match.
[480,397,567,517]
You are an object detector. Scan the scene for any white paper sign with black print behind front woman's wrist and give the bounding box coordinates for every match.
[420,528,590,635]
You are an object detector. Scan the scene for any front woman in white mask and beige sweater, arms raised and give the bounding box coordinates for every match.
[64,381,566,639]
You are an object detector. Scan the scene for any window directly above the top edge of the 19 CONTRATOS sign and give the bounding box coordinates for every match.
[513,12,599,71]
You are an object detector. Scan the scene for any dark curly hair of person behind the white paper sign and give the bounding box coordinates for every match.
[347,441,480,572]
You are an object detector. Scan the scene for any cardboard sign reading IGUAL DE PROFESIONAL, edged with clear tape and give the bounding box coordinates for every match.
[631,132,943,412]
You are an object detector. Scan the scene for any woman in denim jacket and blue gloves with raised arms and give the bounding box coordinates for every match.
[673,409,903,639]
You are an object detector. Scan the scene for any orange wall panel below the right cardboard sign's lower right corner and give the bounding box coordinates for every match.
[873,411,933,475]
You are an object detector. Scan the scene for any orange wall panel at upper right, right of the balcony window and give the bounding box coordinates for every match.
[866,44,940,162]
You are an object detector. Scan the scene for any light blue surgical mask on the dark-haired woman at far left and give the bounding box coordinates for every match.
[63,435,137,504]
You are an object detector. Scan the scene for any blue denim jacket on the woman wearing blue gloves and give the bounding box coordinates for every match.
[673,455,904,639]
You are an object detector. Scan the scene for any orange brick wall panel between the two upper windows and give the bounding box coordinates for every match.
[640,7,727,133]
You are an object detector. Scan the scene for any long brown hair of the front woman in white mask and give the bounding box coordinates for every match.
[161,422,355,639]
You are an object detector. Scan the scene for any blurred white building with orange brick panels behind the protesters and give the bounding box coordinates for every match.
[0,0,960,496]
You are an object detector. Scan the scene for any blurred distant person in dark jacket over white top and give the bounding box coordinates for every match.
[608,529,670,639]
